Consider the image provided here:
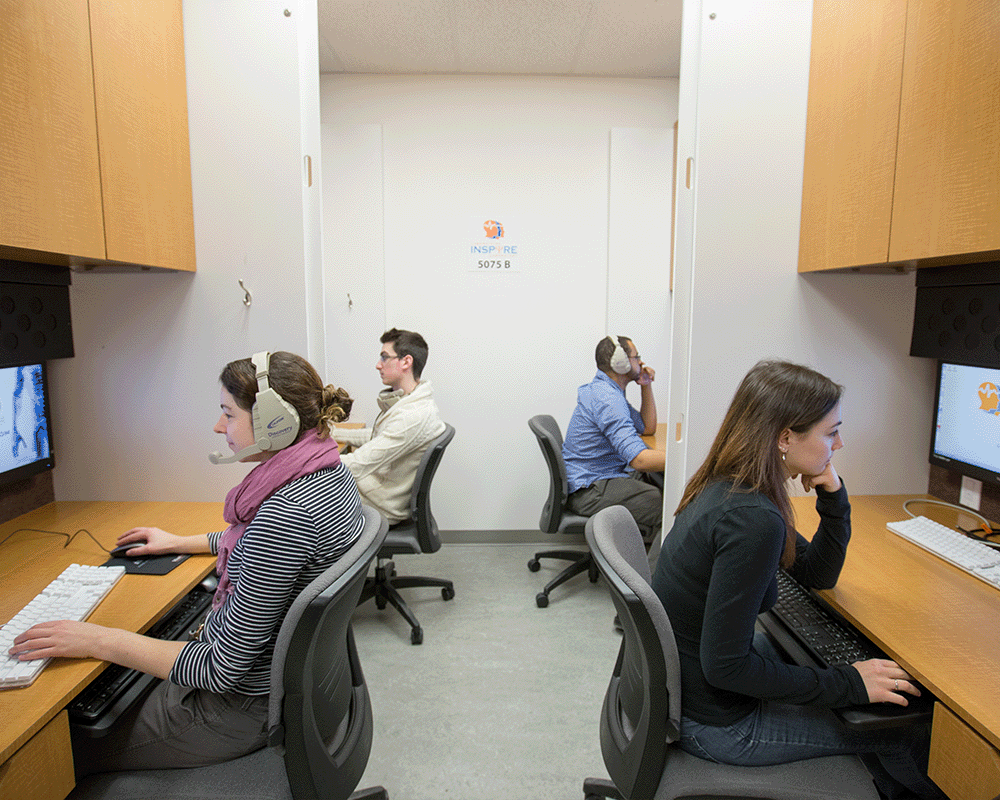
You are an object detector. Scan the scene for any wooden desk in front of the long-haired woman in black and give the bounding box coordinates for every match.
[792,495,1000,800]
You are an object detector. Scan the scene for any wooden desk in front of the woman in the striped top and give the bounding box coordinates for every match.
[0,502,225,797]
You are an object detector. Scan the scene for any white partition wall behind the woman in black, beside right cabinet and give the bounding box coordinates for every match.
[667,0,933,508]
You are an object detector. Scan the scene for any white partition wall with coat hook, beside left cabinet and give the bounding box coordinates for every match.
[50,0,318,500]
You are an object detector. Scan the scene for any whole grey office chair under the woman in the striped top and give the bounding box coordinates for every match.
[70,507,388,800]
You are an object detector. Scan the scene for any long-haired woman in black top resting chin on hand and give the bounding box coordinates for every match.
[653,362,944,798]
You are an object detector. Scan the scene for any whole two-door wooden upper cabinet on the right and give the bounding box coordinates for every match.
[799,0,1000,272]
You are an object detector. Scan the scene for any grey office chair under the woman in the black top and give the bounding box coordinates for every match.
[583,506,878,800]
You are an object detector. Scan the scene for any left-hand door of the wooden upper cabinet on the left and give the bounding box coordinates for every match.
[0,0,104,259]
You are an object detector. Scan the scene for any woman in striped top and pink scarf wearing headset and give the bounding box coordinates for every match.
[10,352,364,775]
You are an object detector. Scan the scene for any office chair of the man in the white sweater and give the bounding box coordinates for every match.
[358,423,455,644]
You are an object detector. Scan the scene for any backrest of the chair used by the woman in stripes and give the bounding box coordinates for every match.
[269,507,388,800]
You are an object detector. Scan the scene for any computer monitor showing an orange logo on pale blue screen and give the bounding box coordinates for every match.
[930,361,1000,485]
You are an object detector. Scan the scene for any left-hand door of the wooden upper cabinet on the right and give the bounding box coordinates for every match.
[799,0,906,272]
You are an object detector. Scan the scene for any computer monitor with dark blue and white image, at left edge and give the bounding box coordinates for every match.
[0,364,55,484]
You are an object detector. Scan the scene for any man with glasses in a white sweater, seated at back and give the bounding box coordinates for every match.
[332,328,444,525]
